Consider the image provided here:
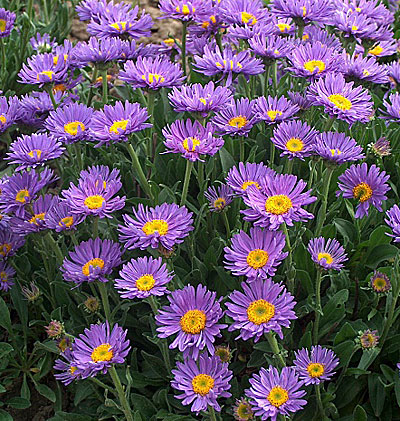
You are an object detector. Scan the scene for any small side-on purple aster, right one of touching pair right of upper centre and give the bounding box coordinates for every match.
[254,96,300,124]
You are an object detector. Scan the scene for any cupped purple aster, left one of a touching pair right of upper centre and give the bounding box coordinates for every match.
[212,98,257,136]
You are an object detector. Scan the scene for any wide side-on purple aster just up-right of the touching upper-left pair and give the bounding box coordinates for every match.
[119,57,185,90]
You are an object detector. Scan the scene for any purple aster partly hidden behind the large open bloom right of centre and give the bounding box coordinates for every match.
[226,162,275,196]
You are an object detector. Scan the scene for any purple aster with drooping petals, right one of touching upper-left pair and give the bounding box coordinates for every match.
[90,101,152,148]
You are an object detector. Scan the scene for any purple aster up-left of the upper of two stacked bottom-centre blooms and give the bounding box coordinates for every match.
[114,257,174,299]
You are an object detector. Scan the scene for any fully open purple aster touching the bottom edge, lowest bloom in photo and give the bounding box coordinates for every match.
[246,365,307,421]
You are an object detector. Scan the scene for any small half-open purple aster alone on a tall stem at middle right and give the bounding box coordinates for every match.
[307,237,348,270]
